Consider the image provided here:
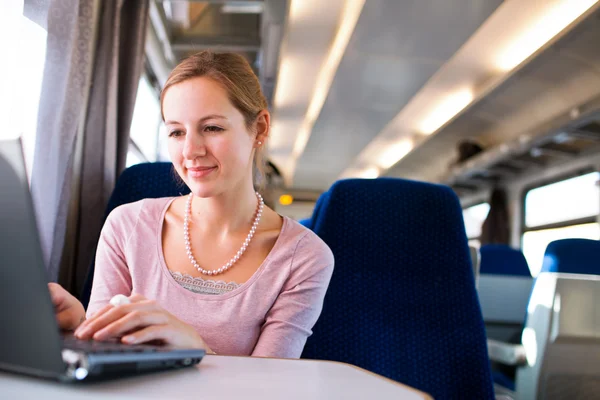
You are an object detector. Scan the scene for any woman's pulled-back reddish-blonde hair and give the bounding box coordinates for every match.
[160,50,268,186]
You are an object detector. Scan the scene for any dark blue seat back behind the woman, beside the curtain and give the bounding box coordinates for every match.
[81,162,190,309]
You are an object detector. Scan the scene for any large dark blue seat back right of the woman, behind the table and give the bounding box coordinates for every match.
[302,178,493,399]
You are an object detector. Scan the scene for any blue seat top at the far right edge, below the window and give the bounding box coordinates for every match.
[541,239,600,275]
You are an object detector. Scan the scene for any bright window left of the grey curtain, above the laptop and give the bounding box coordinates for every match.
[0,0,47,178]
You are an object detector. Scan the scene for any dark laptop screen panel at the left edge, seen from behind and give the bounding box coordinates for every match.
[0,139,65,374]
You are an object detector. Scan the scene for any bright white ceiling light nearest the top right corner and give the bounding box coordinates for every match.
[496,0,597,71]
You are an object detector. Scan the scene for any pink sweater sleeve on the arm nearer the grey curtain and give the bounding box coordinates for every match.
[86,202,142,318]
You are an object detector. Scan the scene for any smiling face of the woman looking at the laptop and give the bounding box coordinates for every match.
[163,77,268,197]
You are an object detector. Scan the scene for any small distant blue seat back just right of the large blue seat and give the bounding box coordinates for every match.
[479,244,531,278]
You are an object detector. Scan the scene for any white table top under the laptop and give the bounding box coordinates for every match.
[0,356,431,400]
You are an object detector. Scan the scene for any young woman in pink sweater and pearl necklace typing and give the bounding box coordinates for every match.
[50,51,333,358]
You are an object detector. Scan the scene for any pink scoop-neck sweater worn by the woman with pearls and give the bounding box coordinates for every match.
[87,198,333,358]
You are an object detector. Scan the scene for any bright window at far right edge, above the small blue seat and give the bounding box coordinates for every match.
[522,172,600,276]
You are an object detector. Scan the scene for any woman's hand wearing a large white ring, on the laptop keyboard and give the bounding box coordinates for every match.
[75,295,214,354]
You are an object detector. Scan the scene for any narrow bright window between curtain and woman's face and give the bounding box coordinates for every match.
[127,76,161,167]
